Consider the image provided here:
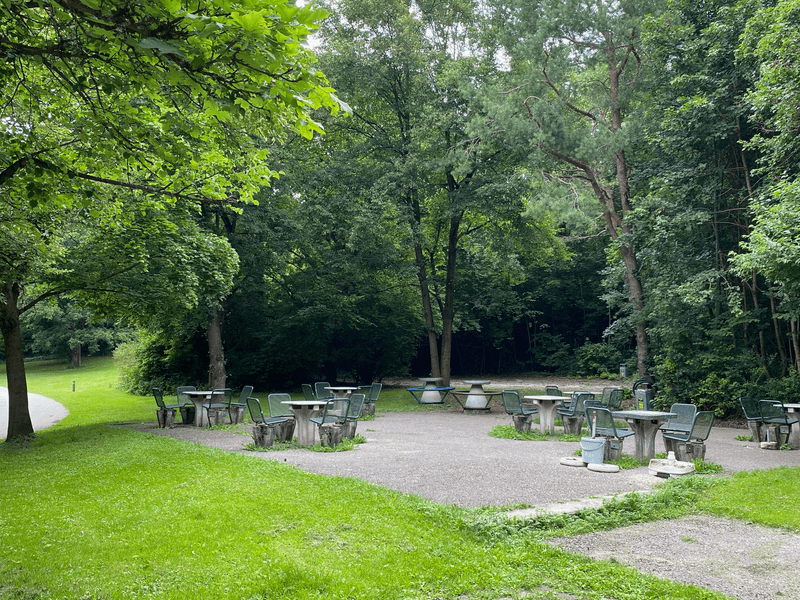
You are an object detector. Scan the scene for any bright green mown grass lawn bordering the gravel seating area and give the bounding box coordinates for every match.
[0,359,800,600]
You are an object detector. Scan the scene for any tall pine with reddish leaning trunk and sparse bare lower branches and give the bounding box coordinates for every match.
[487,0,658,376]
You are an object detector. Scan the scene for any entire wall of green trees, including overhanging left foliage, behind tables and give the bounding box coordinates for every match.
[0,0,800,440]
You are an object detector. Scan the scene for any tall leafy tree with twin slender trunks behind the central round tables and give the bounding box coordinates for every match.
[320,0,559,384]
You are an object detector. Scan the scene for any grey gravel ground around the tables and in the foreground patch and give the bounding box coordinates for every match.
[125,378,800,600]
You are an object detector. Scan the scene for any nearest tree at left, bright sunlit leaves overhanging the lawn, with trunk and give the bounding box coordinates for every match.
[0,0,339,439]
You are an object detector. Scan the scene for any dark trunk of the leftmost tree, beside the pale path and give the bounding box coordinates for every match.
[0,281,33,441]
